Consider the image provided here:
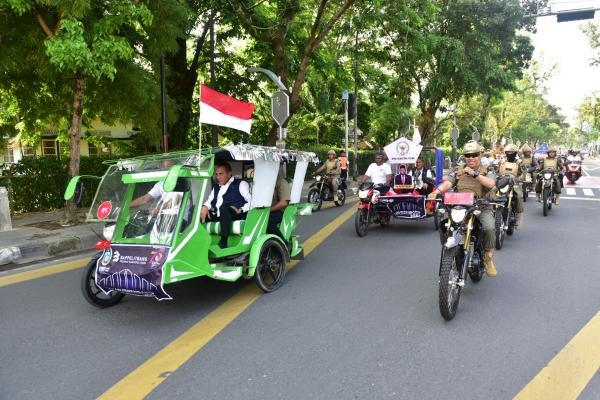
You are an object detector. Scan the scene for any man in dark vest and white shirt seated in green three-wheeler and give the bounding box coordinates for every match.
[200,163,251,249]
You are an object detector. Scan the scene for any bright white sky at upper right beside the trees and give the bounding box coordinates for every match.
[533,0,600,124]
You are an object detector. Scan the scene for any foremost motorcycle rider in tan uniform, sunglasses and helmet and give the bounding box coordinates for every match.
[428,140,497,277]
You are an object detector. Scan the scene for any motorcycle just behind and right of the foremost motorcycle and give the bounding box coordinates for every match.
[495,175,518,250]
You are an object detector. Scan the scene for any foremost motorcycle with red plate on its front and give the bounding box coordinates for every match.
[438,192,494,321]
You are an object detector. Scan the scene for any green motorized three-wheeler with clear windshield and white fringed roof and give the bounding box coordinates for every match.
[65,144,318,307]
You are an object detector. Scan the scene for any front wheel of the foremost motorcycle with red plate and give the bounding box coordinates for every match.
[439,248,462,321]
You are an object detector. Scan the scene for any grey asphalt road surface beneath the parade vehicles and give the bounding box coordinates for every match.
[0,160,600,400]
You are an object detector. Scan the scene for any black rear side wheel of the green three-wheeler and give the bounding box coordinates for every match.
[254,240,286,293]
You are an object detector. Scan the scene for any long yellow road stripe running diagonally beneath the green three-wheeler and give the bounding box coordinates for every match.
[99,208,356,399]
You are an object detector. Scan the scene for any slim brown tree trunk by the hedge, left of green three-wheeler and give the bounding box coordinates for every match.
[65,72,85,224]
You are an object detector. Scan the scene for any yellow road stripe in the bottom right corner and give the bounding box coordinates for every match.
[515,312,600,400]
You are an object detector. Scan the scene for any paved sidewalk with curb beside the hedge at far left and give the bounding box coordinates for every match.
[0,180,357,271]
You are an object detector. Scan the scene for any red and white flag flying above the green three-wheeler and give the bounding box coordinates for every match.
[200,84,254,133]
